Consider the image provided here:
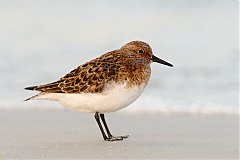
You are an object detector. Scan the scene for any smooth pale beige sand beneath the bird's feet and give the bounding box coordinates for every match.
[0,110,239,159]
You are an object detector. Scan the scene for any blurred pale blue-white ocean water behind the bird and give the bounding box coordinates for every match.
[0,0,239,113]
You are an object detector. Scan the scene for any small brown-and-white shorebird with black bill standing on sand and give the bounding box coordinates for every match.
[25,41,173,141]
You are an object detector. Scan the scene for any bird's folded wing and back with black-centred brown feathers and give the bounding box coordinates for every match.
[26,51,127,93]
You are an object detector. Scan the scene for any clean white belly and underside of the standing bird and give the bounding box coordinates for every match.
[33,84,145,113]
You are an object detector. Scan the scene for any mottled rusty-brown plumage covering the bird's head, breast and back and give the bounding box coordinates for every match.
[26,41,152,93]
